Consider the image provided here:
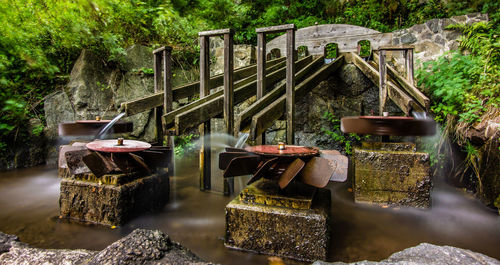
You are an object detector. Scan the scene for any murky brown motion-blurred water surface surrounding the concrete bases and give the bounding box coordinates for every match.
[0,158,500,264]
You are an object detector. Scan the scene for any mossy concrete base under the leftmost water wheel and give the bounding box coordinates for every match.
[59,172,169,226]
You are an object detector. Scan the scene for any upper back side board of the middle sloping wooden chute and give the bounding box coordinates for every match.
[163,58,285,130]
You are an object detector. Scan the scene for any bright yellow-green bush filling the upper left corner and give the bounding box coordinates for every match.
[0,0,196,147]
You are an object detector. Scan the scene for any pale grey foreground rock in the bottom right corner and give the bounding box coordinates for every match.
[313,243,500,265]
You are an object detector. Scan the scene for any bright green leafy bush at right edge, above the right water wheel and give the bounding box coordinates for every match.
[417,17,500,124]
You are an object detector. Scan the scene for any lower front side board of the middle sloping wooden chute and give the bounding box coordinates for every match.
[175,56,312,135]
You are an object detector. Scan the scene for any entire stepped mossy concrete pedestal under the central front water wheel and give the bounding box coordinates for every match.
[225,179,330,261]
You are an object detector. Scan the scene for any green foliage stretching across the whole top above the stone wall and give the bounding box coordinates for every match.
[0,0,499,151]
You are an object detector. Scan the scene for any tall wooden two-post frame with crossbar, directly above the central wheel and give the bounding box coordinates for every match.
[255,24,297,144]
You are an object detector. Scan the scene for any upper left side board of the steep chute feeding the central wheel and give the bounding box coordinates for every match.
[234,56,324,135]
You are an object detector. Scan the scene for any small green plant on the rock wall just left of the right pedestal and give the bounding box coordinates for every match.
[321,111,370,155]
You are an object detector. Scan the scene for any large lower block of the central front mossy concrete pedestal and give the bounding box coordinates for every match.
[225,178,330,261]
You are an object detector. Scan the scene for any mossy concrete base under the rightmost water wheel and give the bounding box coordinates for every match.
[354,143,432,208]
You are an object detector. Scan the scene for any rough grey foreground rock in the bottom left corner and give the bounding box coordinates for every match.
[0,229,211,265]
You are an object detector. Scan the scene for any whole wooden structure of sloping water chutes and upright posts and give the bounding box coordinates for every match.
[121,24,429,194]
